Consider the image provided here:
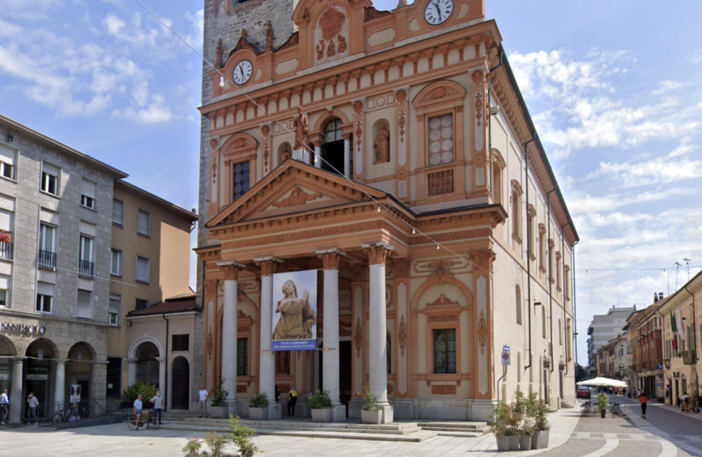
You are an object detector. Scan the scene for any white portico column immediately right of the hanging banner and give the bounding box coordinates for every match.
[317,249,346,422]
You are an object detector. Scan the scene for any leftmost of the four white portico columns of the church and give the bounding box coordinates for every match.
[217,261,244,416]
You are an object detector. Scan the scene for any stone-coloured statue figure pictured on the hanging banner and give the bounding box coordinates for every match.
[273,280,317,341]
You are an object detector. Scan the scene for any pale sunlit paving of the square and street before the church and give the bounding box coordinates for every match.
[0,397,702,457]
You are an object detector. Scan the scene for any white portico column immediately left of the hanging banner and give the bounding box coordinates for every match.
[254,257,281,419]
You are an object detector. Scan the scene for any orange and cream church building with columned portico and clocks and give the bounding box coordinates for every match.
[194,0,578,422]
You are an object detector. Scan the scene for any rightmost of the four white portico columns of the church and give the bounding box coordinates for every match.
[362,242,393,424]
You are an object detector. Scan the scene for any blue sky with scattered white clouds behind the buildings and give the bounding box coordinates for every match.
[0,0,702,364]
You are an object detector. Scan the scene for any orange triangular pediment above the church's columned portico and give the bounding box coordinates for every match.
[207,159,387,228]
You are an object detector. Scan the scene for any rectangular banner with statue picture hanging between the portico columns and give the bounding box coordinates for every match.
[273,270,317,351]
